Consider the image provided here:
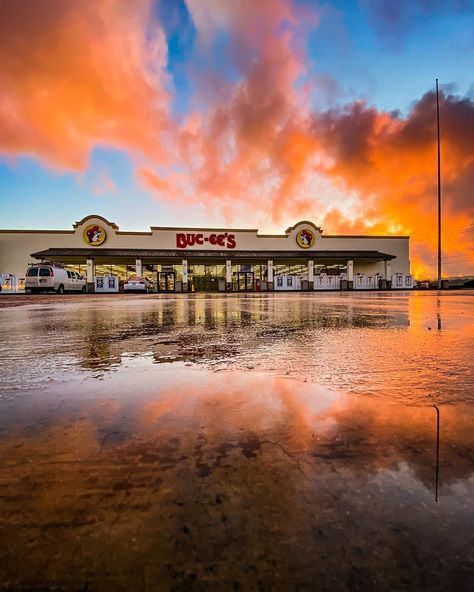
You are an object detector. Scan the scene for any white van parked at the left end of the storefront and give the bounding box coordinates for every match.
[25,263,87,294]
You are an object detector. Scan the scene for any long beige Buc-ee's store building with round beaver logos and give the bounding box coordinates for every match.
[0,215,412,292]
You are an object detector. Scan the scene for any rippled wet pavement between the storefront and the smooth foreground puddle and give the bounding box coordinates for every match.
[0,291,474,404]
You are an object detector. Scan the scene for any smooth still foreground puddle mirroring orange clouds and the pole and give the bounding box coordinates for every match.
[0,368,474,590]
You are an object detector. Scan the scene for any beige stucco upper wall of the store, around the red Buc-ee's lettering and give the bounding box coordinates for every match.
[0,216,410,276]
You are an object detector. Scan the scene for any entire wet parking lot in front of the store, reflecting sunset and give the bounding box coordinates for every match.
[0,292,474,591]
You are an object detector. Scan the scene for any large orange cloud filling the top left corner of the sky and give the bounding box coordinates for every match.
[0,0,171,170]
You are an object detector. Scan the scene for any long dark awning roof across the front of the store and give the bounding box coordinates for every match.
[31,248,395,261]
